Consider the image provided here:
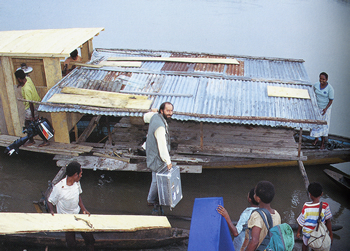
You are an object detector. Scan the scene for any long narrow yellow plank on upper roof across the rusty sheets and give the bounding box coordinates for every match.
[107,57,239,64]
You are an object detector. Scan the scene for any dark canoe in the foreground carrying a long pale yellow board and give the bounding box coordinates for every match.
[0,213,189,249]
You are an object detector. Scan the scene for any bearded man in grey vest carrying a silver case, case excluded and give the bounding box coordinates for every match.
[143,102,174,214]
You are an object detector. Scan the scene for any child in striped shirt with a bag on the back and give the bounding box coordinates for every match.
[297,182,333,251]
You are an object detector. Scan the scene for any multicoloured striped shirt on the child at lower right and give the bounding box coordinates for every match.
[297,202,332,238]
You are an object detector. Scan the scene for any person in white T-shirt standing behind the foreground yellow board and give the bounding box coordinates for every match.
[47,161,95,251]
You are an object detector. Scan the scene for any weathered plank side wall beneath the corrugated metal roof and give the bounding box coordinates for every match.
[113,118,298,160]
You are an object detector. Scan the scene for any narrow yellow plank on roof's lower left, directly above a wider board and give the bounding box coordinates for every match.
[61,87,147,100]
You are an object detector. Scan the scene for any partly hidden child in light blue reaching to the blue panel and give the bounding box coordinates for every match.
[217,188,259,251]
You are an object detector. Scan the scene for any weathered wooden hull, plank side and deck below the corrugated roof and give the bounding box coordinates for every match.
[0,117,350,173]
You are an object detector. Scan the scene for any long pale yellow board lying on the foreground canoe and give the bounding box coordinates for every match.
[0,213,171,234]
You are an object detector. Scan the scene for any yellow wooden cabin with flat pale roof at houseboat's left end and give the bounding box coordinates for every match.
[0,28,103,142]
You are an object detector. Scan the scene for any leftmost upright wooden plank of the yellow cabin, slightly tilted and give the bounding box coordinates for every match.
[0,57,23,136]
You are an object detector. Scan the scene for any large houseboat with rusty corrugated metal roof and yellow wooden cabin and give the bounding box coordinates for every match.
[0,28,350,173]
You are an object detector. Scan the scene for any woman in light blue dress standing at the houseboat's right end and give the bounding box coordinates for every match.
[310,72,334,150]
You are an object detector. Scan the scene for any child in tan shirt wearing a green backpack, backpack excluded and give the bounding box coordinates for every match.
[241,181,282,251]
